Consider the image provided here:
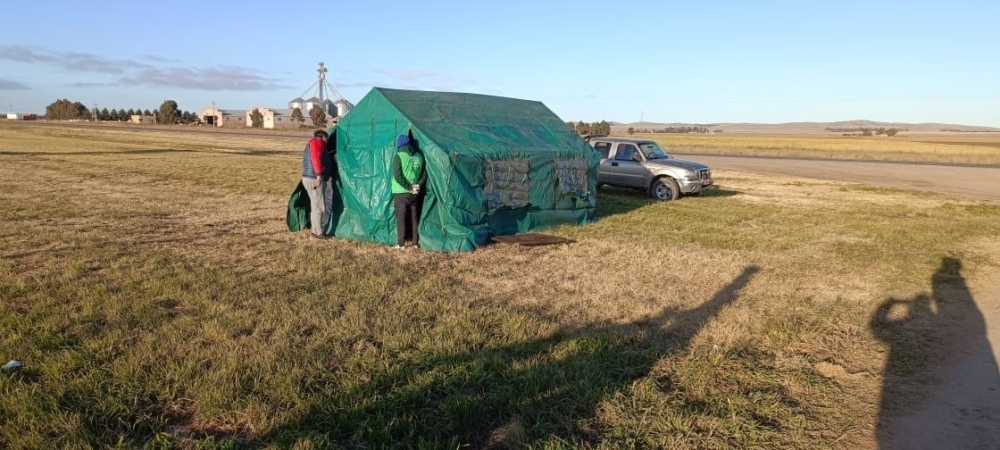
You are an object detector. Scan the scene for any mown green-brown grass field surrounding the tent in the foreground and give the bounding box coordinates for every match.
[0,121,1000,449]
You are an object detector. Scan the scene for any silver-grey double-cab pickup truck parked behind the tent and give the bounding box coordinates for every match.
[587,136,715,200]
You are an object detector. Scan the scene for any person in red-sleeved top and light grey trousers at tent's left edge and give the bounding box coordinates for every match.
[302,130,333,239]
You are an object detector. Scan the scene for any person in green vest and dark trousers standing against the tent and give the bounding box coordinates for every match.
[392,134,427,249]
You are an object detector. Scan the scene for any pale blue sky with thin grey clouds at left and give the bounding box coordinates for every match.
[0,0,1000,126]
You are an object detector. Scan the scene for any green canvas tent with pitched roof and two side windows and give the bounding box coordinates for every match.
[322,88,600,251]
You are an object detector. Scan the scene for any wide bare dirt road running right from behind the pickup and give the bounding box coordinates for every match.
[675,153,1000,203]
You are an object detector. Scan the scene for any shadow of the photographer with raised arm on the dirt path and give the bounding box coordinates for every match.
[870,257,1000,449]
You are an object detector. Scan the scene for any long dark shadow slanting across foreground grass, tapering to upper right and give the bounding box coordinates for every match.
[259,267,759,448]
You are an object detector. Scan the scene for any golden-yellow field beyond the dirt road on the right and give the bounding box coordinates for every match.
[634,133,1000,164]
